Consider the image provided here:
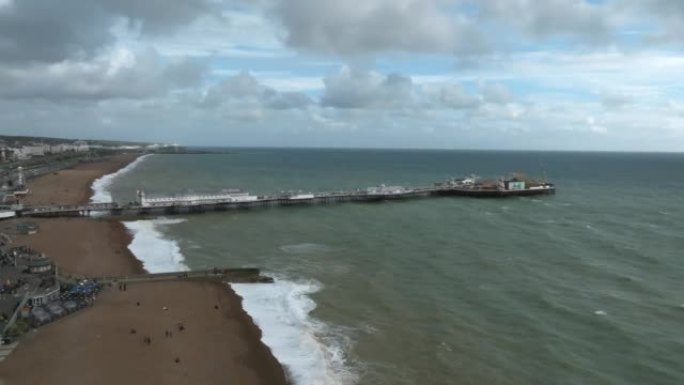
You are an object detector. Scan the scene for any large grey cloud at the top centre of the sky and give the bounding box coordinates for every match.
[262,0,484,56]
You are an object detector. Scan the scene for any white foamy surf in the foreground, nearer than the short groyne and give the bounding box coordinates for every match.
[231,278,357,385]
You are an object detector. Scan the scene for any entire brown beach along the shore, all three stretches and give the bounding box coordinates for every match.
[0,155,287,385]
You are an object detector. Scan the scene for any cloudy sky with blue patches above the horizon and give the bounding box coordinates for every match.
[0,0,684,152]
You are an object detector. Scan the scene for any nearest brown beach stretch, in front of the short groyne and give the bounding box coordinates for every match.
[0,281,285,385]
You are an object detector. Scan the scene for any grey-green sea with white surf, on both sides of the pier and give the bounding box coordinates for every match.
[93,148,684,385]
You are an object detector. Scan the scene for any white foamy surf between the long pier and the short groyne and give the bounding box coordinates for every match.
[123,218,188,273]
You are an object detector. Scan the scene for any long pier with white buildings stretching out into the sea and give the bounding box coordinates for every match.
[10,181,555,217]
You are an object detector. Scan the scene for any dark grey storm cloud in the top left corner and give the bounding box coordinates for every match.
[0,0,213,63]
